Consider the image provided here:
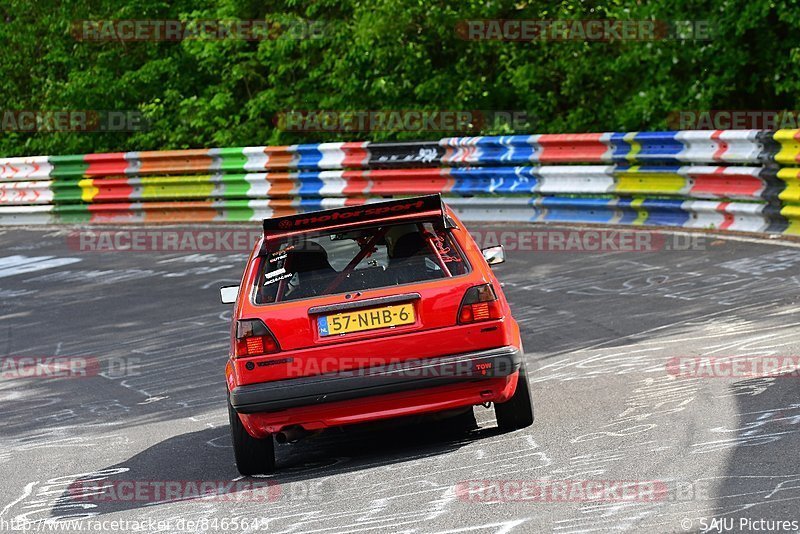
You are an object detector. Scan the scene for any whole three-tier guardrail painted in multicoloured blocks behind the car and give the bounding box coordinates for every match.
[0,130,800,235]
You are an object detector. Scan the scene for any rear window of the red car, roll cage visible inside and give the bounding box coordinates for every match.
[254,222,470,304]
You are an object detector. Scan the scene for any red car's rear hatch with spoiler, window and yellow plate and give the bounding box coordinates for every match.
[236,195,502,382]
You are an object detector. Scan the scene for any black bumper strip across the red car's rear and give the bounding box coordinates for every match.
[230,346,523,414]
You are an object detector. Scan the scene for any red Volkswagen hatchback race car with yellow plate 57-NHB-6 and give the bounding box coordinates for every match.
[221,195,533,475]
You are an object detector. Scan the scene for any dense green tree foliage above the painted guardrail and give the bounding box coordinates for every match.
[0,0,800,156]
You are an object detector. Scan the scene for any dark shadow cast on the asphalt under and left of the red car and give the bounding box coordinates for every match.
[52,411,500,518]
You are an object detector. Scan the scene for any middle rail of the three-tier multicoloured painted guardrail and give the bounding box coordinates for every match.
[37,165,780,204]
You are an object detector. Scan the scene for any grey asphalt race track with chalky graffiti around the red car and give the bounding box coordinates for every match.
[0,227,800,533]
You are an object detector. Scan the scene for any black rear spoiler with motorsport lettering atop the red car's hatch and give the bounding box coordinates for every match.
[264,194,456,239]
